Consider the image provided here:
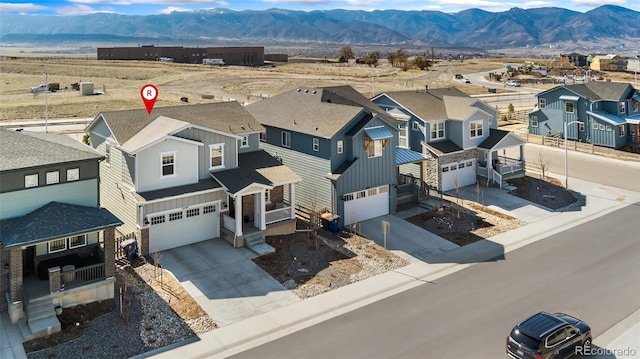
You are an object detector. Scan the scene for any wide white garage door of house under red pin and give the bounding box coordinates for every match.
[149,203,220,252]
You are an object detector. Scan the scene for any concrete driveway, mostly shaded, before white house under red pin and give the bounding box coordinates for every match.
[160,238,300,327]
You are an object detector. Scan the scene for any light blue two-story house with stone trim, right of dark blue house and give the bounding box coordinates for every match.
[372,88,525,191]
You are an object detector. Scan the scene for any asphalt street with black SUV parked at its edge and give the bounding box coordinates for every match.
[234,203,640,359]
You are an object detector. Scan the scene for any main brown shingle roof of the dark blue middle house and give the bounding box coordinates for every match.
[246,86,397,138]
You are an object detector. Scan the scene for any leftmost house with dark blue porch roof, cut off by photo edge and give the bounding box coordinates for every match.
[0,128,122,337]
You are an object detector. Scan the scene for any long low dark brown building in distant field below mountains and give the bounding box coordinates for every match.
[98,45,264,66]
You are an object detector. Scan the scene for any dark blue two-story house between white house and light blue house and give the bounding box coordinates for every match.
[247,86,424,225]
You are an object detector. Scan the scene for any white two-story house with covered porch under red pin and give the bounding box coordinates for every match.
[87,102,300,254]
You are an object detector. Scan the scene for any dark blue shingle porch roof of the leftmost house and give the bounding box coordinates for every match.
[0,202,123,248]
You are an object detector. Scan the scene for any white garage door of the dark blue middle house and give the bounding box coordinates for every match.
[344,185,389,225]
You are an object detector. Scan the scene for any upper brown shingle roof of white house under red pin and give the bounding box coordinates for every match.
[86,101,264,145]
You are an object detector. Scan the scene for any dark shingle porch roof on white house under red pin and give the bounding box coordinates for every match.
[211,150,300,194]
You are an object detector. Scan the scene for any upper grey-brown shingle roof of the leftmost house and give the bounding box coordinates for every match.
[0,129,103,171]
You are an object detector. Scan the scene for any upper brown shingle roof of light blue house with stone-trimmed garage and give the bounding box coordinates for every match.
[375,87,470,121]
